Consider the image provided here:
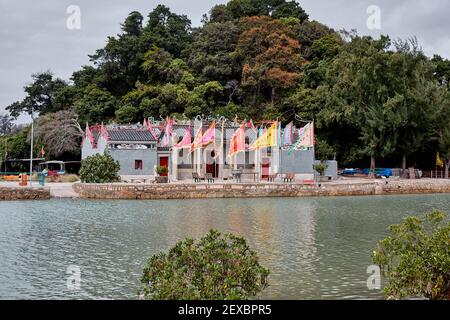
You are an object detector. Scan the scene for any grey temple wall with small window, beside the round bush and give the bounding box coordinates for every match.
[107,149,158,176]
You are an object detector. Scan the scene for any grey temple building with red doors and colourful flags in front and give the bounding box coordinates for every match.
[82,120,337,181]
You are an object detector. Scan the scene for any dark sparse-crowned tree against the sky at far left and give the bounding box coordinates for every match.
[6,71,67,118]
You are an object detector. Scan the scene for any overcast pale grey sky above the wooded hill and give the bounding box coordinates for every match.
[0,0,450,121]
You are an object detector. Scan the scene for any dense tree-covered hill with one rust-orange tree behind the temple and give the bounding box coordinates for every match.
[5,0,450,170]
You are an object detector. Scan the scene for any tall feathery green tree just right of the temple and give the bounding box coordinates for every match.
[321,36,405,176]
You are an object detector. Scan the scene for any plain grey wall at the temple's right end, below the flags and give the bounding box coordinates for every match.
[279,150,314,174]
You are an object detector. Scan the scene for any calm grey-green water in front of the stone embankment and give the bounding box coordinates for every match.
[0,195,450,299]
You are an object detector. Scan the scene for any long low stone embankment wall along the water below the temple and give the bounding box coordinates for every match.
[73,179,450,199]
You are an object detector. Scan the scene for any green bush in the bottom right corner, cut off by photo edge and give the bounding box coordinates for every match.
[372,211,450,300]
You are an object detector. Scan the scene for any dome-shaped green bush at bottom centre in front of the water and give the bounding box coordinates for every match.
[141,230,269,300]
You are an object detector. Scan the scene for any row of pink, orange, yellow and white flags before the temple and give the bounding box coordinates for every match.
[144,118,315,156]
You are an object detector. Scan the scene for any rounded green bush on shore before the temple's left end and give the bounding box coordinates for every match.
[80,153,120,183]
